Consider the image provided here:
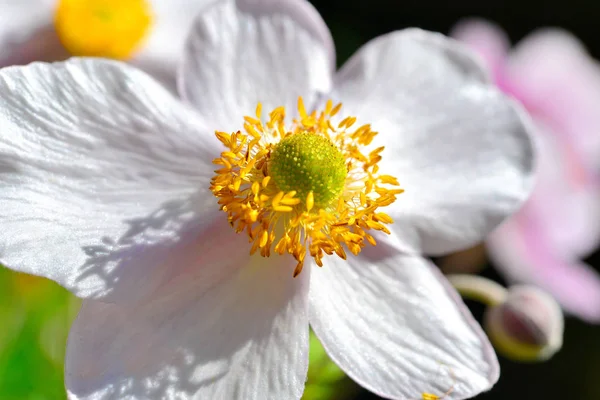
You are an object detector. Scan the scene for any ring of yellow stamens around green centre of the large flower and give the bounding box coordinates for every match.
[211,98,403,276]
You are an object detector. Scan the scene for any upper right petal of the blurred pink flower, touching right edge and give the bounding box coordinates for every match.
[507,29,600,169]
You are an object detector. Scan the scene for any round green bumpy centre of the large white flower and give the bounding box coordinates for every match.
[269,132,348,209]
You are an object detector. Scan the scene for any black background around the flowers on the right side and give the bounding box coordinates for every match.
[312,0,600,400]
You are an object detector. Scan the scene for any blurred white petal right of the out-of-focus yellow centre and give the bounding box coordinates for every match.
[131,0,216,91]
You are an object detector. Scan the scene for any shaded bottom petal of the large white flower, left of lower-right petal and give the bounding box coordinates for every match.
[66,250,310,400]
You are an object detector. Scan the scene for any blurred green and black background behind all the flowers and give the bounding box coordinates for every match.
[0,0,600,400]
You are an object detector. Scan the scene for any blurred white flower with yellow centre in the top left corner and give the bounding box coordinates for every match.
[0,0,209,85]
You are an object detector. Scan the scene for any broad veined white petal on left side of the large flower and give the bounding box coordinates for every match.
[0,59,216,297]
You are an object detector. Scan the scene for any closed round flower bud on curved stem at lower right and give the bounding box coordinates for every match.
[485,286,564,362]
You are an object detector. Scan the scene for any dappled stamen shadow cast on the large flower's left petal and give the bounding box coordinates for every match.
[75,193,232,302]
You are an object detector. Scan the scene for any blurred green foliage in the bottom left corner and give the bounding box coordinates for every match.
[0,266,79,400]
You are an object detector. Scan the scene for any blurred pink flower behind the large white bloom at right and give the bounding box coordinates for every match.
[452,20,600,322]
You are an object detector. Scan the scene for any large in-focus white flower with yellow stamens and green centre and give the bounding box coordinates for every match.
[0,0,532,400]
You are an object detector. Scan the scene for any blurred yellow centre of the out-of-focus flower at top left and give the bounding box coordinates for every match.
[55,0,152,59]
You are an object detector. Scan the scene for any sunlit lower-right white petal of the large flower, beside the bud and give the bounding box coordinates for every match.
[310,234,499,400]
